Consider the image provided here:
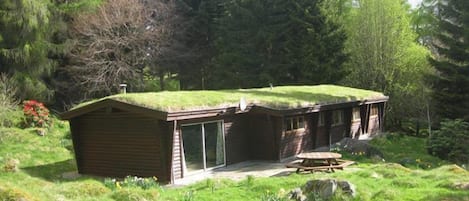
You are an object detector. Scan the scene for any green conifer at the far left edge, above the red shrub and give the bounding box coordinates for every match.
[0,0,55,101]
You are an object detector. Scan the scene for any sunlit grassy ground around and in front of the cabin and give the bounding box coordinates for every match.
[0,123,469,200]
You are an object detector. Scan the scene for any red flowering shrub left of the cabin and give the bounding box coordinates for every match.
[23,100,51,128]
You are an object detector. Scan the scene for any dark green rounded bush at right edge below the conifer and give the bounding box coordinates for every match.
[428,119,469,164]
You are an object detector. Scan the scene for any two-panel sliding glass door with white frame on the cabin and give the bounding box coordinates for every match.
[181,121,225,172]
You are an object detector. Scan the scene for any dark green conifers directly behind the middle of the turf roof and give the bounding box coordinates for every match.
[209,0,346,88]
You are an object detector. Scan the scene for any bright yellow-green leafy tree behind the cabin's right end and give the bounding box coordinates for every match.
[343,0,432,128]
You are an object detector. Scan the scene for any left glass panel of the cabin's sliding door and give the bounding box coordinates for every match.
[181,124,204,172]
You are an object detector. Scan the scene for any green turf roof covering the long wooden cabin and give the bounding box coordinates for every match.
[76,85,386,112]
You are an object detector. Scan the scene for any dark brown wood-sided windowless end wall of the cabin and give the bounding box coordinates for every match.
[68,109,168,180]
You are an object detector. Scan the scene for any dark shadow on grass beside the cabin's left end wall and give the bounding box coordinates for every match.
[21,159,77,181]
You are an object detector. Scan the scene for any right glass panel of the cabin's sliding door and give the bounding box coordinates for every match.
[204,122,225,168]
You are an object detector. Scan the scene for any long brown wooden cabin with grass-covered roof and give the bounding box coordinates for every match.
[61,85,388,182]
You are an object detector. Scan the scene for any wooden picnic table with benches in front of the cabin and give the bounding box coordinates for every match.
[286,152,354,173]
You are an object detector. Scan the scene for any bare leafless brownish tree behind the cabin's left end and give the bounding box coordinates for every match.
[62,0,174,98]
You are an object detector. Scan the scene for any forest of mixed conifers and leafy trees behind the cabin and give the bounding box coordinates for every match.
[0,0,469,138]
